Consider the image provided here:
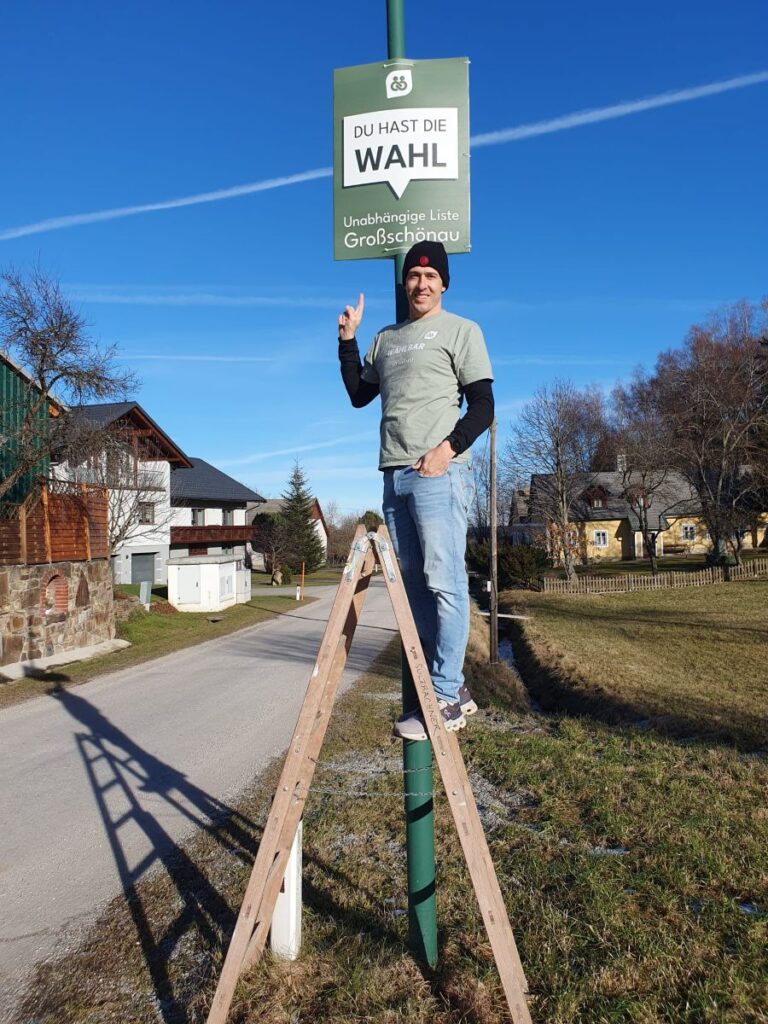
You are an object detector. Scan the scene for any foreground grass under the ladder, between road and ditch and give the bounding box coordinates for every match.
[13,595,768,1024]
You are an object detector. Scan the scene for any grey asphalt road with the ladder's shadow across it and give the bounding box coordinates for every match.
[0,581,395,1020]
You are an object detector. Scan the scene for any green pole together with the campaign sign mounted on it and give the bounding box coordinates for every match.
[334,9,470,967]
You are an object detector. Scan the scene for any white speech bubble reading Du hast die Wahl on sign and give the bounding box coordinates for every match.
[343,106,459,199]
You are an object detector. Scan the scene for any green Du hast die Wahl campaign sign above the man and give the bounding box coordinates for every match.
[334,57,470,259]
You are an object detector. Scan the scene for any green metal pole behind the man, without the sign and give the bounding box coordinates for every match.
[387,0,437,967]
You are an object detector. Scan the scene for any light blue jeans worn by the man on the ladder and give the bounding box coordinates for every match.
[383,462,474,703]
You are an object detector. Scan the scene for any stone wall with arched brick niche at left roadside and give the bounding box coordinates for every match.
[0,558,115,667]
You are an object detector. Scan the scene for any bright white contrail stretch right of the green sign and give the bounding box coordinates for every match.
[472,71,768,148]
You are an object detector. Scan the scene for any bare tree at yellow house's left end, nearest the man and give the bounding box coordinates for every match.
[504,380,605,580]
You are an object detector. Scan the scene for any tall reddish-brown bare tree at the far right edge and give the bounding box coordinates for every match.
[650,300,768,559]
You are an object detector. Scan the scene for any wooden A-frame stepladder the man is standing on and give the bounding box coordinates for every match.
[208,526,530,1024]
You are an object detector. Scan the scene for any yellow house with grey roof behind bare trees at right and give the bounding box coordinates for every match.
[528,472,768,562]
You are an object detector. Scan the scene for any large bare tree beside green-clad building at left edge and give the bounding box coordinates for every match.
[0,266,135,498]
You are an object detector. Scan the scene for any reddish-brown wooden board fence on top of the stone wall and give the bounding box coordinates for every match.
[0,480,110,565]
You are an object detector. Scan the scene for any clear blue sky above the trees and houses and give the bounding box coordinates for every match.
[0,0,768,511]
